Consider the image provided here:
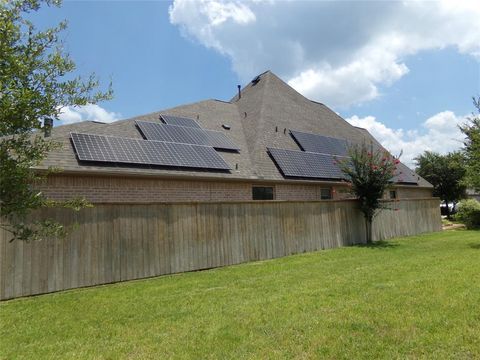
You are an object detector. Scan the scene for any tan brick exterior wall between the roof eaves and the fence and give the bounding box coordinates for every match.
[36,176,431,203]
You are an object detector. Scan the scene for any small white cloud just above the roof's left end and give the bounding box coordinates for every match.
[58,104,120,125]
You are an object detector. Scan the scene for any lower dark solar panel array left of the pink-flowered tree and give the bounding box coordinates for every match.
[268,148,345,180]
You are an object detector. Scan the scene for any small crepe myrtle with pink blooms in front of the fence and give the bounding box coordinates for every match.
[335,143,400,244]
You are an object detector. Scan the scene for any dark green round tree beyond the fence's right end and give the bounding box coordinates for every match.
[415,151,466,218]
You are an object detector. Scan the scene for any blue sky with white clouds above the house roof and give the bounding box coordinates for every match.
[30,0,480,166]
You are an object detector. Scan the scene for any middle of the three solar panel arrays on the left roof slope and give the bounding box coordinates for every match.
[136,121,239,151]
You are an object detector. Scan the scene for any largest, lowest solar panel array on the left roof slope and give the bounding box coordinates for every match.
[71,133,230,170]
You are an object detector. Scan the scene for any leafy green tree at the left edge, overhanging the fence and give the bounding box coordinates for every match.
[0,0,112,240]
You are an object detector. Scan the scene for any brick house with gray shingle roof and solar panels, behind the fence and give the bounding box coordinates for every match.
[33,71,432,203]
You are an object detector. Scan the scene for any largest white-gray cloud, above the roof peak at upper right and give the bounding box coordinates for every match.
[169,0,480,107]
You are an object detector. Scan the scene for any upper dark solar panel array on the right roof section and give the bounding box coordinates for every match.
[290,130,348,156]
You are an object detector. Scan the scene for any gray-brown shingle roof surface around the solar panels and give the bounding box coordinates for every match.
[40,71,429,186]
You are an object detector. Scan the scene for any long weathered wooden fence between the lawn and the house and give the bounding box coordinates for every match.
[0,198,441,300]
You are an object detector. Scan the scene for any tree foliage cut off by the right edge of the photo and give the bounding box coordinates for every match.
[460,96,480,191]
